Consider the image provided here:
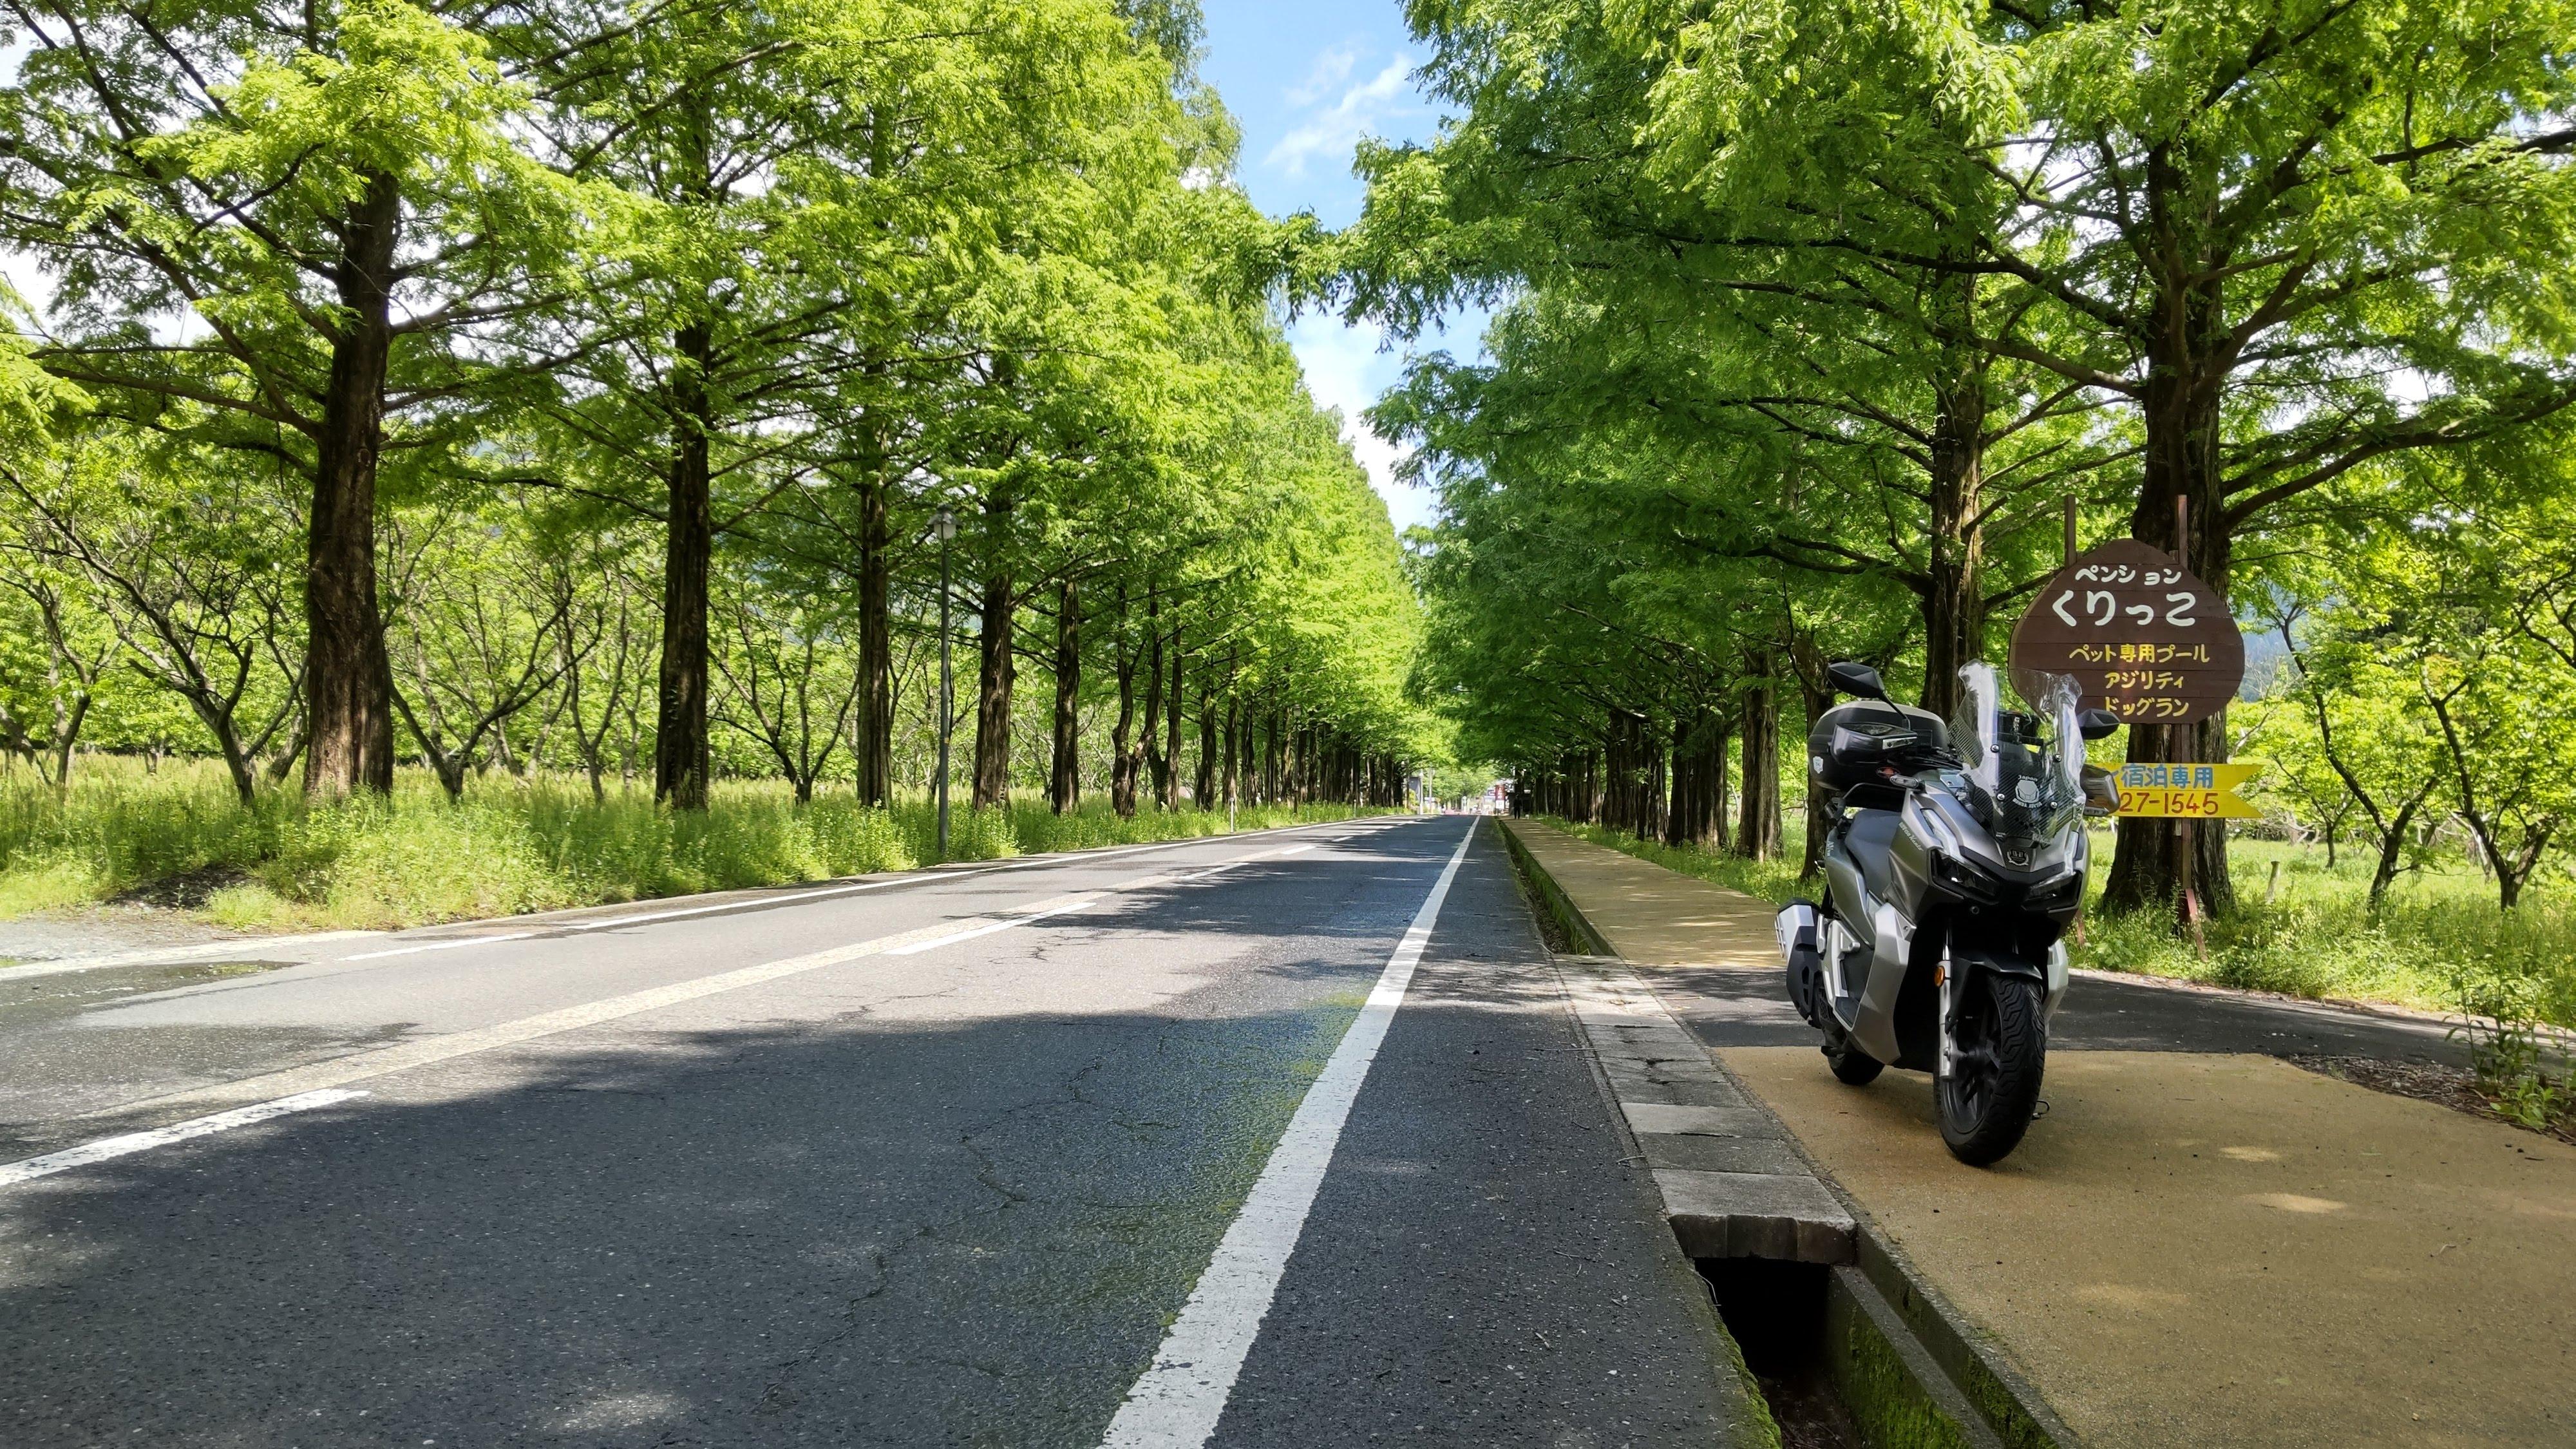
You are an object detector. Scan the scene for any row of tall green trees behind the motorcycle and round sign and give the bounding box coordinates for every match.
[1309,0,2576,910]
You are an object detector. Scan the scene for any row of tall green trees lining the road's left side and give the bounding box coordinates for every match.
[0,0,1419,810]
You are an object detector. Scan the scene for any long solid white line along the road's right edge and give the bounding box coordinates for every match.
[1100,822,1476,1449]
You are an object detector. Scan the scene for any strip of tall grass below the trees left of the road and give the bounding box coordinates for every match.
[0,761,1391,931]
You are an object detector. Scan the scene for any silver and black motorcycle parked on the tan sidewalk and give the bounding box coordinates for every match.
[1777,663,2120,1166]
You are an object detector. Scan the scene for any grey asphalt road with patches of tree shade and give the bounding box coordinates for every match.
[0,820,1741,1449]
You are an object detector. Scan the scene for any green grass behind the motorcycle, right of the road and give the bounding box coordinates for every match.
[1558,822,2576,1026]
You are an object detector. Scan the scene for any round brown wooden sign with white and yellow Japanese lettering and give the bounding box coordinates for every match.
[2012,539,2246,724]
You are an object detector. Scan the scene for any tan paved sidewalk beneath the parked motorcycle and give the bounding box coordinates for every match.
[1512,820,2576,1446]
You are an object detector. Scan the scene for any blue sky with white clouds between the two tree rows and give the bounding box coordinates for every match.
[1200,0,1481,529]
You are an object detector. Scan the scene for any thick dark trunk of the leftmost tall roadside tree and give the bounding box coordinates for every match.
[300,173,402,799]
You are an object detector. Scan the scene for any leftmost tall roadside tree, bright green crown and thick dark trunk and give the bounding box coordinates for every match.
[0,0,582,797]
